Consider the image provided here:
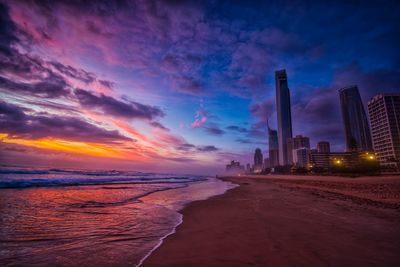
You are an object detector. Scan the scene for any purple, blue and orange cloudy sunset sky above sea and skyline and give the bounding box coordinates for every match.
[0,0,400,174]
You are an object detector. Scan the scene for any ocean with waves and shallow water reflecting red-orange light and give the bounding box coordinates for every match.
[0,168,235,266]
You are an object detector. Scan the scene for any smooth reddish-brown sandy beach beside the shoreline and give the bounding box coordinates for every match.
[143,176,400,266]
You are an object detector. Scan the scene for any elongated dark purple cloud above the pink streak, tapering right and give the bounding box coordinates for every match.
[75,89,165,120]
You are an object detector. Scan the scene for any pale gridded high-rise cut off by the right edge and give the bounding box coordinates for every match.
[368,94,400,169]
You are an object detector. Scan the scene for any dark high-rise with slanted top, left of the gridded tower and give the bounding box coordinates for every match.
[339,86,372,151]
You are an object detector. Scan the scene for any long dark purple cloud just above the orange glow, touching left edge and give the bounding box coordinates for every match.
[0,102,132,143]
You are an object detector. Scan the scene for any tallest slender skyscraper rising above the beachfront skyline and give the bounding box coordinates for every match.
[275,70,292,165]
